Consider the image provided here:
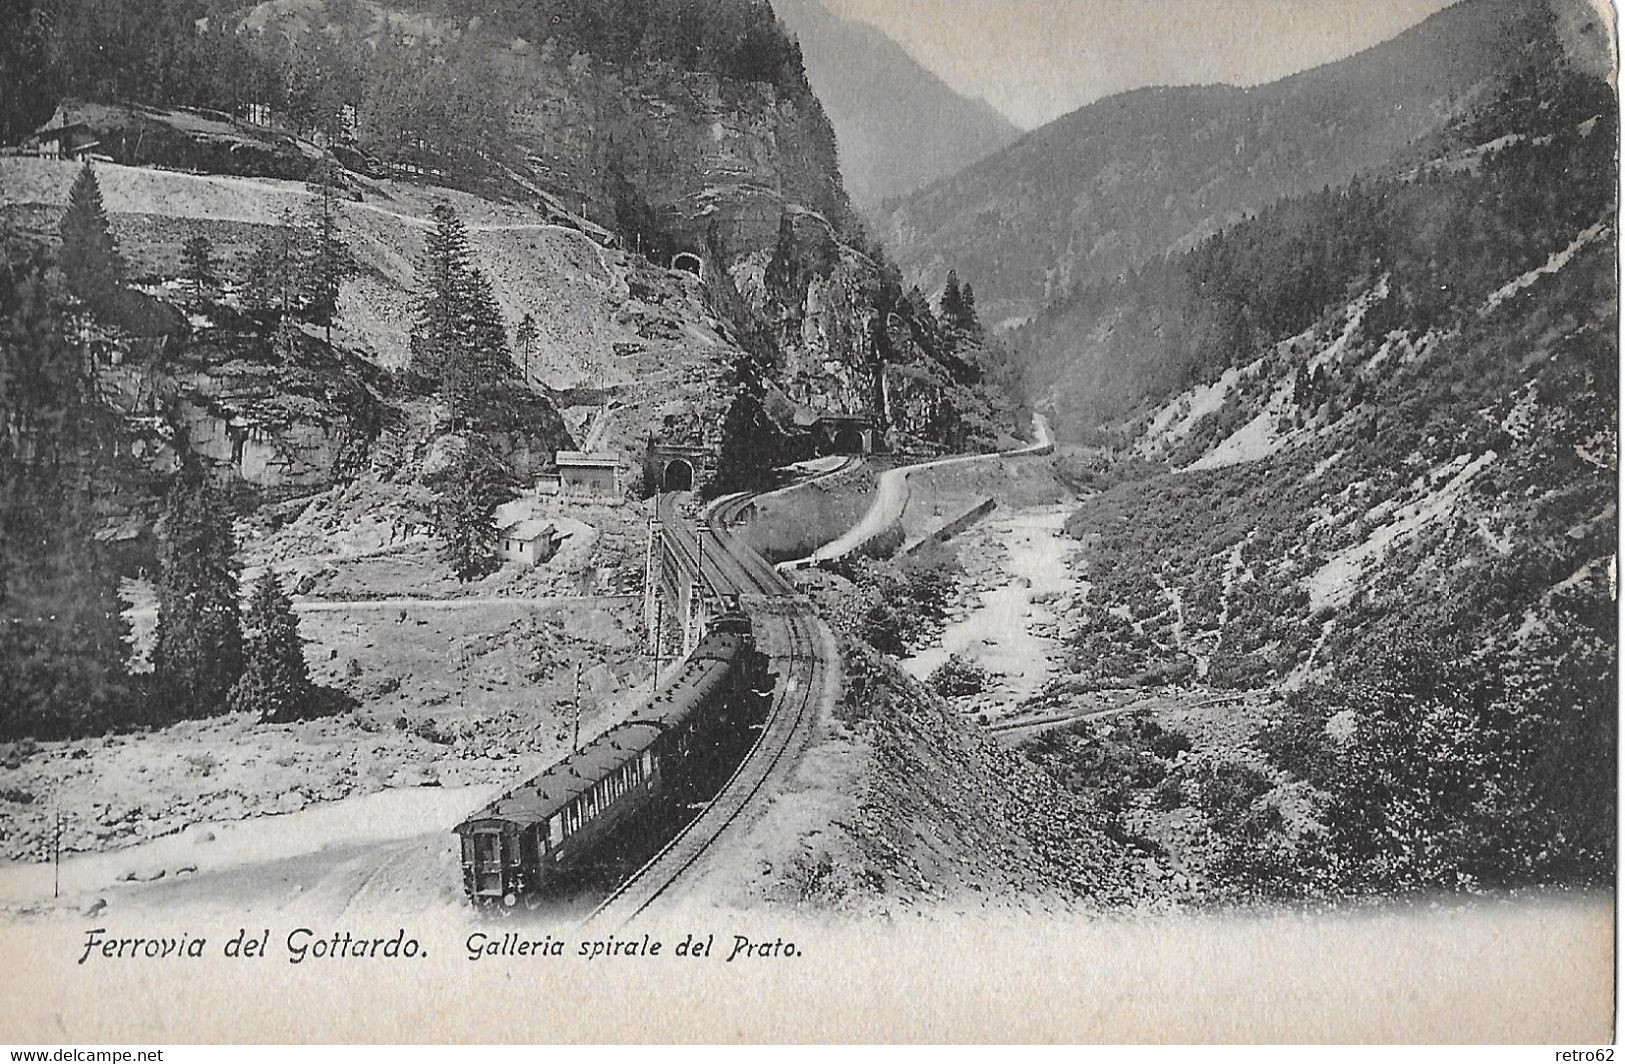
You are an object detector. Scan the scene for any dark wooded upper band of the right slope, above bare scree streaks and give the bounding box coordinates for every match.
[1016,2,1615,439]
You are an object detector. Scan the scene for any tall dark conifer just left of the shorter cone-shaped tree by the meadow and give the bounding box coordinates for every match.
[153,456,242,718]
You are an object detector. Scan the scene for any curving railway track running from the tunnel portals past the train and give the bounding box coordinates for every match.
[588,494,840,926]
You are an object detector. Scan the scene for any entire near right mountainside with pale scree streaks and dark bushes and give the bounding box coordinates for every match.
[1030,21,1619,895]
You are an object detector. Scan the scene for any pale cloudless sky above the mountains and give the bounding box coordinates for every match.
[822,0,1453,128]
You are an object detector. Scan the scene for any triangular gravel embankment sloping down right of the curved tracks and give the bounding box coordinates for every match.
[696,623,1139,916]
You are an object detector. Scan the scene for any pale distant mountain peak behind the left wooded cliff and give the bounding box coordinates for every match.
[774,0,1021,208]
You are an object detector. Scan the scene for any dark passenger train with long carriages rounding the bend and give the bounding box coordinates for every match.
[453,601,770,908]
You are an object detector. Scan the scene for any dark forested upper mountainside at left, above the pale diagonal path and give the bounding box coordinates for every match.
[0,0,848,255]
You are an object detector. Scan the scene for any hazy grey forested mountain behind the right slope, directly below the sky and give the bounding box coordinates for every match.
[879,0,1602,322]
